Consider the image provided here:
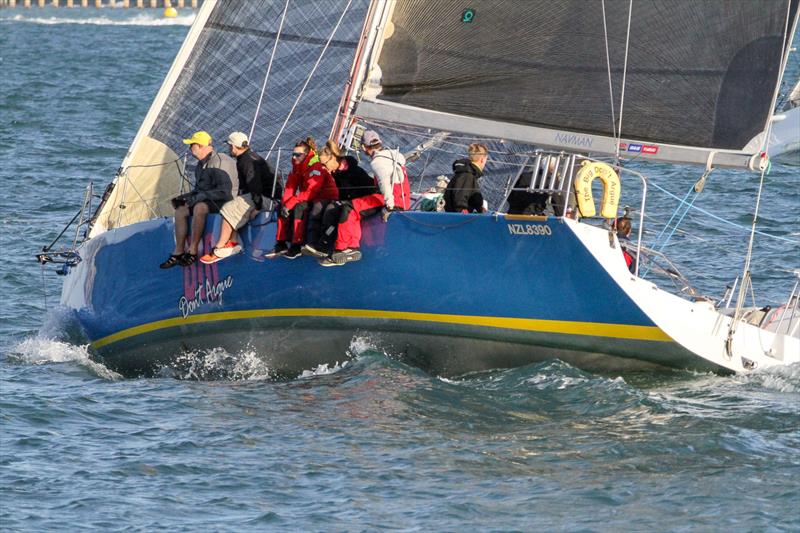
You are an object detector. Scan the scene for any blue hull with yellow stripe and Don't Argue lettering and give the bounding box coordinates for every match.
[62,212,708,375]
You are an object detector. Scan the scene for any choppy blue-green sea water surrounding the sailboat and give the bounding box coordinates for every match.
[0,9,800,531]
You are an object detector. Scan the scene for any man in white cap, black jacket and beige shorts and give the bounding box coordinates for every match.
[200,131,282,265]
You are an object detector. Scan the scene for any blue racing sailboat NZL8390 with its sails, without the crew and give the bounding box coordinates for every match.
[39,0,800,376]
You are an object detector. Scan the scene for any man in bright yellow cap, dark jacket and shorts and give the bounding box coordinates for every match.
[161,131,239,268]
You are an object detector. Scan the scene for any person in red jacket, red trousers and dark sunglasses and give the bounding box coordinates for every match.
[265,137,339,259]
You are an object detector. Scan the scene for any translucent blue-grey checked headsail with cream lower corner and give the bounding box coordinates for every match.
[92,0,368,235]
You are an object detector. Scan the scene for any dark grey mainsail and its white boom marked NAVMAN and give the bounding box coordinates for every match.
[356,0,798,166]
